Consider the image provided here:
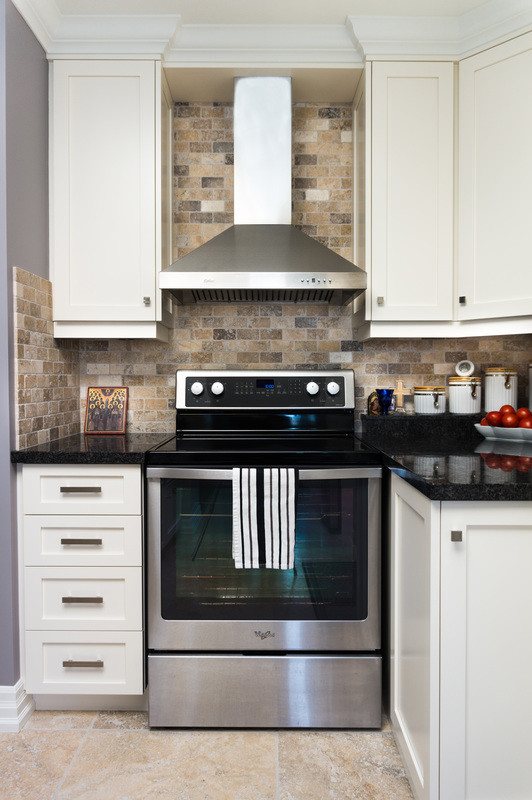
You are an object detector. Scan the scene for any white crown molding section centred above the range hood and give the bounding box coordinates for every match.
[165,25,362,66]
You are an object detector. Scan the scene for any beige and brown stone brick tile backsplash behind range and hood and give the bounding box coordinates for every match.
[15,103,532,440]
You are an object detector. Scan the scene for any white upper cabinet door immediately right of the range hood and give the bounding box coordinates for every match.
[366,61,453,320]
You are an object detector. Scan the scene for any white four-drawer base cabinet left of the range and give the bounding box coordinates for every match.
[19,464,144,695]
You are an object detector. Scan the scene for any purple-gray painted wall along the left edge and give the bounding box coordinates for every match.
[0,0,48,686]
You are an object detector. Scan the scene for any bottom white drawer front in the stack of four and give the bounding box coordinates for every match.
[25,631,144,694]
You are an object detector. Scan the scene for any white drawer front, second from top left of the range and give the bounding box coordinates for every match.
[24,515,142,567]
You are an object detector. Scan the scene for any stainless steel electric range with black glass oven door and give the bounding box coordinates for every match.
[147,370,381,728]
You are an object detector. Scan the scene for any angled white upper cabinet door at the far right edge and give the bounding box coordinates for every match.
[456,34,532,320]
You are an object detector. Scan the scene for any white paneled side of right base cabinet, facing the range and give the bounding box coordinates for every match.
[390,475,440,800]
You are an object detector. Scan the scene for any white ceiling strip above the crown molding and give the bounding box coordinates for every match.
[55,0,486,25]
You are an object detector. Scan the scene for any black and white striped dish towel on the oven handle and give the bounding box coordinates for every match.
[233,467,297,569]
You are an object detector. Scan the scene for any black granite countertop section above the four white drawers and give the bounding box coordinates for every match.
[11,433,171,464]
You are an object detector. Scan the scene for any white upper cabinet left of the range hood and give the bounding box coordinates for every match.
[50,60,168,338]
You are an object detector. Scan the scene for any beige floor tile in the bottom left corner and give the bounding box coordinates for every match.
[0,730,85,800]
